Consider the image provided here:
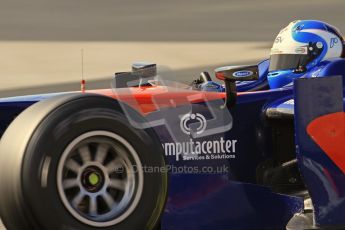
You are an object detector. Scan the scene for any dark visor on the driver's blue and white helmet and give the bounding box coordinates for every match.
[269,54,310,71]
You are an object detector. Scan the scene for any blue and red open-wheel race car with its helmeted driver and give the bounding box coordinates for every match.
[0,20,345,230]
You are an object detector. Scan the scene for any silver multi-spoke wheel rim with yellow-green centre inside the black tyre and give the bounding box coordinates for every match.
[57,131,143,227]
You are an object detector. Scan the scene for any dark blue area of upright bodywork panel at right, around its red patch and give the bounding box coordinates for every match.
[295,76,345,228]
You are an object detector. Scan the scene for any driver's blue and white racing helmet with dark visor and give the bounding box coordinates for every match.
[267,20,344,89]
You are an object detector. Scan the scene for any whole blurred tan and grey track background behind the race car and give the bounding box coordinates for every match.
[0,0,345,229]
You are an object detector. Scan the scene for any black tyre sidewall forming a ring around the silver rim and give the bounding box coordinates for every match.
[22,99,167,230]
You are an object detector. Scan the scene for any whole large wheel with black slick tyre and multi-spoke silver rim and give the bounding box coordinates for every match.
[0,94,167,230]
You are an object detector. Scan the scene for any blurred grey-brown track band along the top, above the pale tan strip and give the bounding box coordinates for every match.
[0,0,345,42]
